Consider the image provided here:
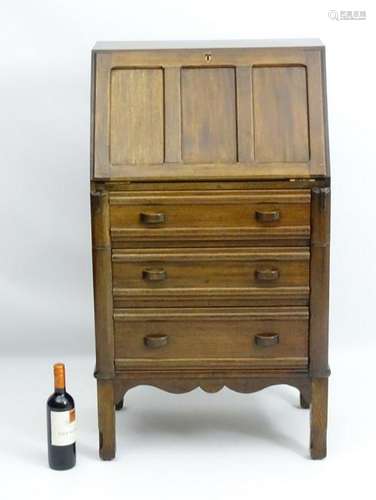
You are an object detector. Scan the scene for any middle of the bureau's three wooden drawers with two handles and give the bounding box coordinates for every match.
[112,247,310,307]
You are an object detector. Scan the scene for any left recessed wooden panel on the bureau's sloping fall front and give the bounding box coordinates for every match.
[110,68,164,165]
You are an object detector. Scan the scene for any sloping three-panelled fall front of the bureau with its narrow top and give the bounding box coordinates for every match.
[91,39,329,181]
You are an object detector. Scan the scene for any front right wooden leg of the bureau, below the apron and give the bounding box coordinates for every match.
[310,378,328,459]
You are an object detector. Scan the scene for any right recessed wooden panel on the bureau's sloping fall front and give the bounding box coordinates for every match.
[252,66,309,162]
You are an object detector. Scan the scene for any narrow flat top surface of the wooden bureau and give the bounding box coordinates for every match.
[93,38,323,52]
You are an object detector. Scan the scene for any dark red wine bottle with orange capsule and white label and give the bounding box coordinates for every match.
[47,363,76,470]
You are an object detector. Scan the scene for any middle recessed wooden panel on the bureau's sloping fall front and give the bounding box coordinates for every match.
[181,68,237,163]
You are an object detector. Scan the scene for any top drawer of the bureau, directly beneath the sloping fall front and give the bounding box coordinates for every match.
[110,189,310,247]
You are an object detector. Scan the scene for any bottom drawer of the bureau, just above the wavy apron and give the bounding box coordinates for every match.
[114,307,308,370]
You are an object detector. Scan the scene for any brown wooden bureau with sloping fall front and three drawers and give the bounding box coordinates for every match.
[91,40,330,459]
